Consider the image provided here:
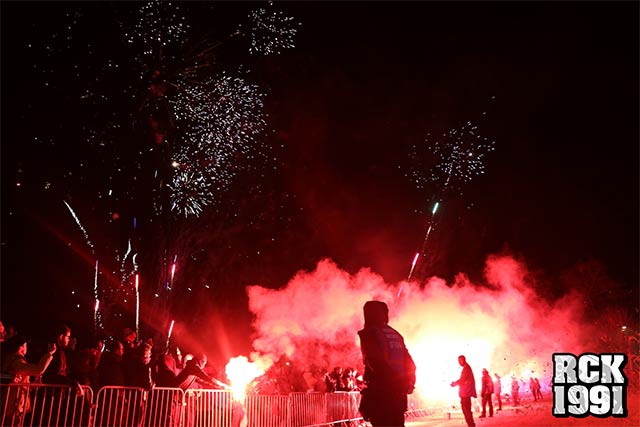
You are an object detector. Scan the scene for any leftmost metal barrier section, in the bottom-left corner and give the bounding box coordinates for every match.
[0,384,93,426]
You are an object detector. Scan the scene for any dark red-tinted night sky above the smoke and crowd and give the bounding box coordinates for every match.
[0,1,639,352]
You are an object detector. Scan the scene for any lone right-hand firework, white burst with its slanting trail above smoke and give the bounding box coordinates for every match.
[408,97,495,280]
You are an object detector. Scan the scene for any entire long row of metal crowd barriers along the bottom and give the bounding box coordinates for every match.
[0,384,427,427]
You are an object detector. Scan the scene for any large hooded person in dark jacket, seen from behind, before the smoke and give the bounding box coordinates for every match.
[358,301,416,427]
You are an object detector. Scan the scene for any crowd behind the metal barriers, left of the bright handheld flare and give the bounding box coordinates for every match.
[0,322,227,394]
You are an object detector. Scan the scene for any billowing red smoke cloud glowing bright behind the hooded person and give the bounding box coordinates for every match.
[247,256,590,403]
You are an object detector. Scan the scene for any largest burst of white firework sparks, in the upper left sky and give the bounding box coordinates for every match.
[169,75,266,217]
